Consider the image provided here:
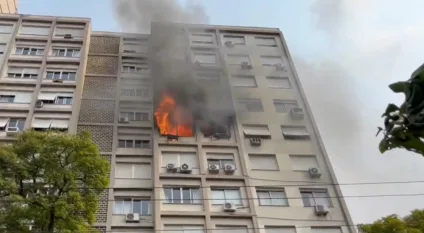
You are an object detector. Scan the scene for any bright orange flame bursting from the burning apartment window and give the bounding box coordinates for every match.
[155,92,194,137]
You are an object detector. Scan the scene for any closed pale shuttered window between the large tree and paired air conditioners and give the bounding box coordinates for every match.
[115,163,152,179]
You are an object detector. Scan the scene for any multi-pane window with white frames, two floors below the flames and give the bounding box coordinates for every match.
[163,187,202,204]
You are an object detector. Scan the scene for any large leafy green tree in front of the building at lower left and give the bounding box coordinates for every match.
[0,131,110,233]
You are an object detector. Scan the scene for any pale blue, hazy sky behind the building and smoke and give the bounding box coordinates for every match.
[19,0,424,223]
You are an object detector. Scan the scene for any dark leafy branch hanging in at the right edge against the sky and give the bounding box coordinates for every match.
[377,64,424,155]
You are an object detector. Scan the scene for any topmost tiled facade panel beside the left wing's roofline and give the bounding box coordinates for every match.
[89,36,120,54]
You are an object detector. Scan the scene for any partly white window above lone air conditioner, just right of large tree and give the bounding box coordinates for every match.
[113,198,152,216]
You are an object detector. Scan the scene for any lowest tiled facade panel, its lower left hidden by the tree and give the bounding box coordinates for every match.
[77,125,113,152]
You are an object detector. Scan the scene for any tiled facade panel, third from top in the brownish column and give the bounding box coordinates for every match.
[83,77,116,98]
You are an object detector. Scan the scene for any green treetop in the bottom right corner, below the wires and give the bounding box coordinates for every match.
[358,210,424,233]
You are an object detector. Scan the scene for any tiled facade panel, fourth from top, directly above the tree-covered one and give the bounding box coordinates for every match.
[79,99,115,123]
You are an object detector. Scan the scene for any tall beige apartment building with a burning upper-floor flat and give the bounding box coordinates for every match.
[0,15,355,233]
